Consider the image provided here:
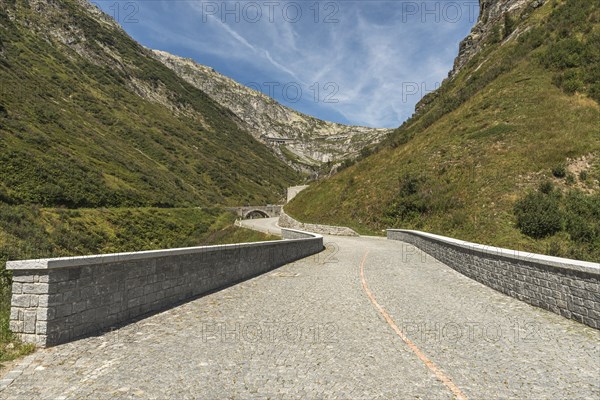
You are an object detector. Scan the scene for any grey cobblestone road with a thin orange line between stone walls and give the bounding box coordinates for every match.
[0,220,600,399]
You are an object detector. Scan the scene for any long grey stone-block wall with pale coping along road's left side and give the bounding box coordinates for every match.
[6,230,323,346]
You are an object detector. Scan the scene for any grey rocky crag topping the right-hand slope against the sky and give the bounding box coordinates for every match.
[448,0,545,78]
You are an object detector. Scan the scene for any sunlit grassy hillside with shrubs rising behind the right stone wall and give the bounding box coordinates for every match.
[286,0,600,261]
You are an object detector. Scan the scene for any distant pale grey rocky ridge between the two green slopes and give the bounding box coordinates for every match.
[153,50,392,172]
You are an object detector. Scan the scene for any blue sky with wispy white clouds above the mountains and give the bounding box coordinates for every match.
[94,0,479,127]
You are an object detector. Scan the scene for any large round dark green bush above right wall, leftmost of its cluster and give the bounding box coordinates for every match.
[514,192,563,239]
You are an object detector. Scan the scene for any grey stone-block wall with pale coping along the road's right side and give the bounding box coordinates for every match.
[387,229,600,329]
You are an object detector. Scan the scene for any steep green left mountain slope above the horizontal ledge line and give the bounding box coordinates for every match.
[0,0,299,207]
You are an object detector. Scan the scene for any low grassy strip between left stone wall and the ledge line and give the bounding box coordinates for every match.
[0,204,278,363]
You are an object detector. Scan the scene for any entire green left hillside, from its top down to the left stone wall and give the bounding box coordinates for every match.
[0,0,299,362]
